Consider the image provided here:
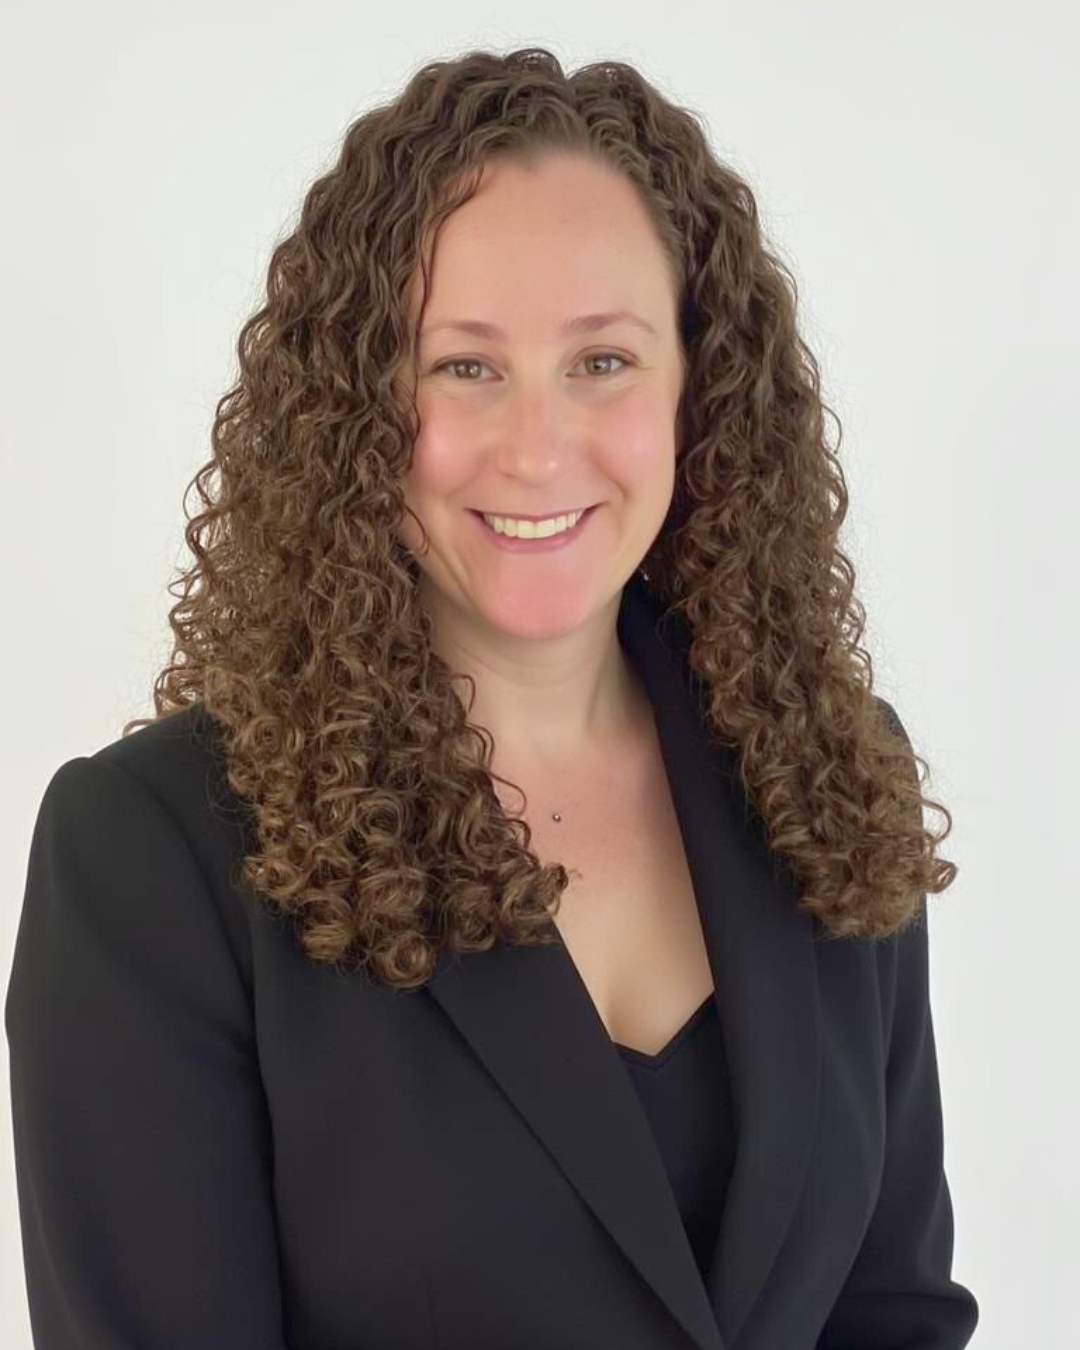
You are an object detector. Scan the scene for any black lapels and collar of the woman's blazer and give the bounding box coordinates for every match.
[425,575,819,1350]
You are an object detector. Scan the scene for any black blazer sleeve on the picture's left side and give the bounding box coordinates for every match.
[4,757,285,1350]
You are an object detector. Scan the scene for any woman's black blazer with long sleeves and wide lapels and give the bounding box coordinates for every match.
[5,579,979,1350]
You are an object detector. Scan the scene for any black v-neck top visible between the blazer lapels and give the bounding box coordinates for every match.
[616,994,734,1278]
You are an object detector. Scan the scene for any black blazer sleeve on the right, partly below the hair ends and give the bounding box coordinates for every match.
[817,705,979,1350]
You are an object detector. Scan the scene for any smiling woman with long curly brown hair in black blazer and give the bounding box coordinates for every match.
[5,42,977,1350]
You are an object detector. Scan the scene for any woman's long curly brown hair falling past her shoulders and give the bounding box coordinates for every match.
[123,47,956,988]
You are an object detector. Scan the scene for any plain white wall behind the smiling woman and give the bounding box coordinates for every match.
[0,0,1080,1350]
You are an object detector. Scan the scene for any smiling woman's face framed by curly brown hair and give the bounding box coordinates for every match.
[400,155,683,637]
